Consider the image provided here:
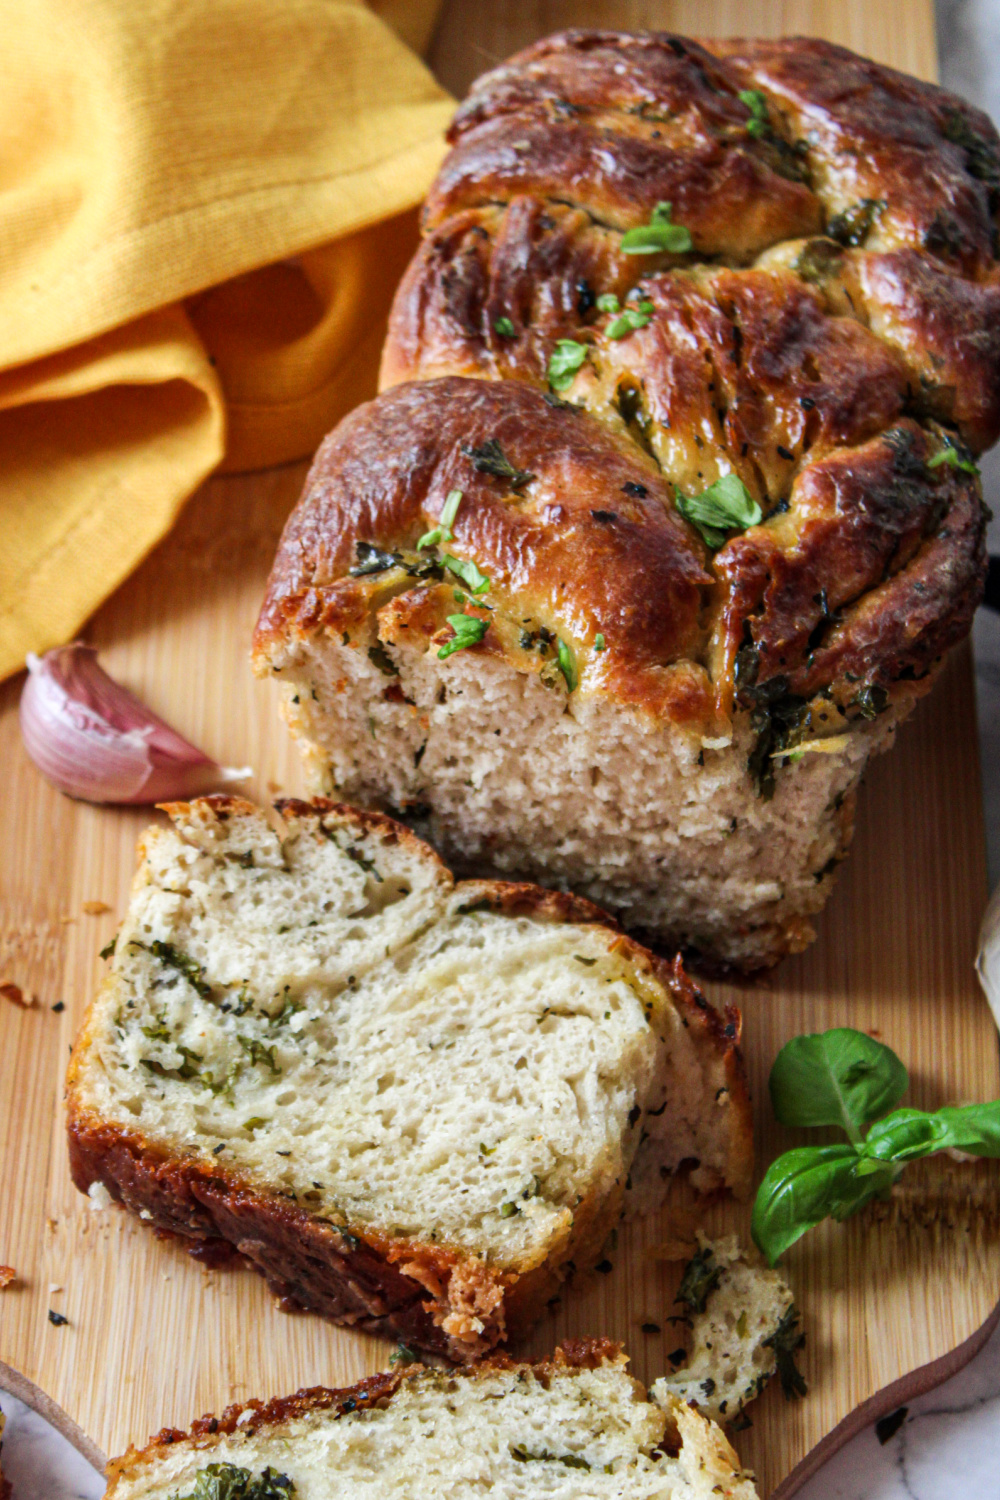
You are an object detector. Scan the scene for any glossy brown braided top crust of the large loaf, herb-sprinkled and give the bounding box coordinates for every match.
[258,30,1000,725]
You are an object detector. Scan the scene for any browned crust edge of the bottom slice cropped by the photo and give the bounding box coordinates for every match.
[106,1338,628,1497]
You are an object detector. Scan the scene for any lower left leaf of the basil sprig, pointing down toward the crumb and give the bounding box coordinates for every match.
[751,1145,895,1266]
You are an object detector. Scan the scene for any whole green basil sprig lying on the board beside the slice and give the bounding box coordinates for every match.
[753,1026,1000,1266]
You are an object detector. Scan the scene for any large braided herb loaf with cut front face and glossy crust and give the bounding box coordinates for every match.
[255,32,1000,971]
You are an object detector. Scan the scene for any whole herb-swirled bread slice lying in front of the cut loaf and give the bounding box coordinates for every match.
[69,797,751,1361]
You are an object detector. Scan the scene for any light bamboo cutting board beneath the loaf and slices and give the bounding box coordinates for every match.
[0,0,1000,1497]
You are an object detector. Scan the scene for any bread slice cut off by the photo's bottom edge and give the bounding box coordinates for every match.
[106,1340,757,1500]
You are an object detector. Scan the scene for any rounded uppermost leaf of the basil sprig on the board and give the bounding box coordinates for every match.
[769,1026,910,1143]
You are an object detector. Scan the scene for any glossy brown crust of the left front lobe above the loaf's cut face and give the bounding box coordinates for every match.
[255,378,711,719]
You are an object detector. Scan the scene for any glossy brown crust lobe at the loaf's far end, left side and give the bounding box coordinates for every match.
[424,32,820,258]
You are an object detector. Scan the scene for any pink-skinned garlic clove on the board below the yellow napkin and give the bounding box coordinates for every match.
[19,641,250,804]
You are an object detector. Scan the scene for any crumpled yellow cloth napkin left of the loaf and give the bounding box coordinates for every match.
[0,0,453,677]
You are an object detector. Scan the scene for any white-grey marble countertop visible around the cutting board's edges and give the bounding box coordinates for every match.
[0,0,1000,1500]
